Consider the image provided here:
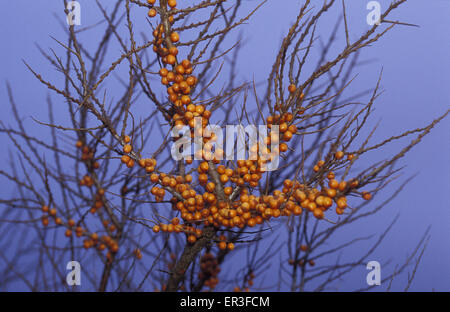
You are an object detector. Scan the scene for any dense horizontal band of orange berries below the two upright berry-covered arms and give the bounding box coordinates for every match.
[150,166,362,241]
